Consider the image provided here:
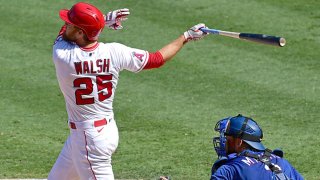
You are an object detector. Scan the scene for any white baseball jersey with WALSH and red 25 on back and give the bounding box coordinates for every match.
[53,36,149,122]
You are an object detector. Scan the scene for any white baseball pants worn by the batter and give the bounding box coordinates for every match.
[48,119,119,180]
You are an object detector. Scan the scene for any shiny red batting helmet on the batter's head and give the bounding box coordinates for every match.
[59,2,105,41]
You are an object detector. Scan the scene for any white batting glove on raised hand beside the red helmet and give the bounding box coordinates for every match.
[105,8,130,30]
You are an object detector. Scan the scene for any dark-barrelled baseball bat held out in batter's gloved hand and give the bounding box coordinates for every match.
[200,28,286,47]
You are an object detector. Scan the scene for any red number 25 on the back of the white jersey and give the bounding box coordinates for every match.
[73,74,112,105]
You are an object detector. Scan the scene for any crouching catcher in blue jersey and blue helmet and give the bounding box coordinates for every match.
[211,114,303,180]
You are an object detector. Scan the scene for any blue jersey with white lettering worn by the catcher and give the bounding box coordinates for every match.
[211,151,303,180]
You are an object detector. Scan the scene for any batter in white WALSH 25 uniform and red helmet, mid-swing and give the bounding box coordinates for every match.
[48,2,206,180]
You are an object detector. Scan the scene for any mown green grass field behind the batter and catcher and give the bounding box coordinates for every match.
[0,0,320,180]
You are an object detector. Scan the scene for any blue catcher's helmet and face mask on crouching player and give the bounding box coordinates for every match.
[213,114,266,157]
